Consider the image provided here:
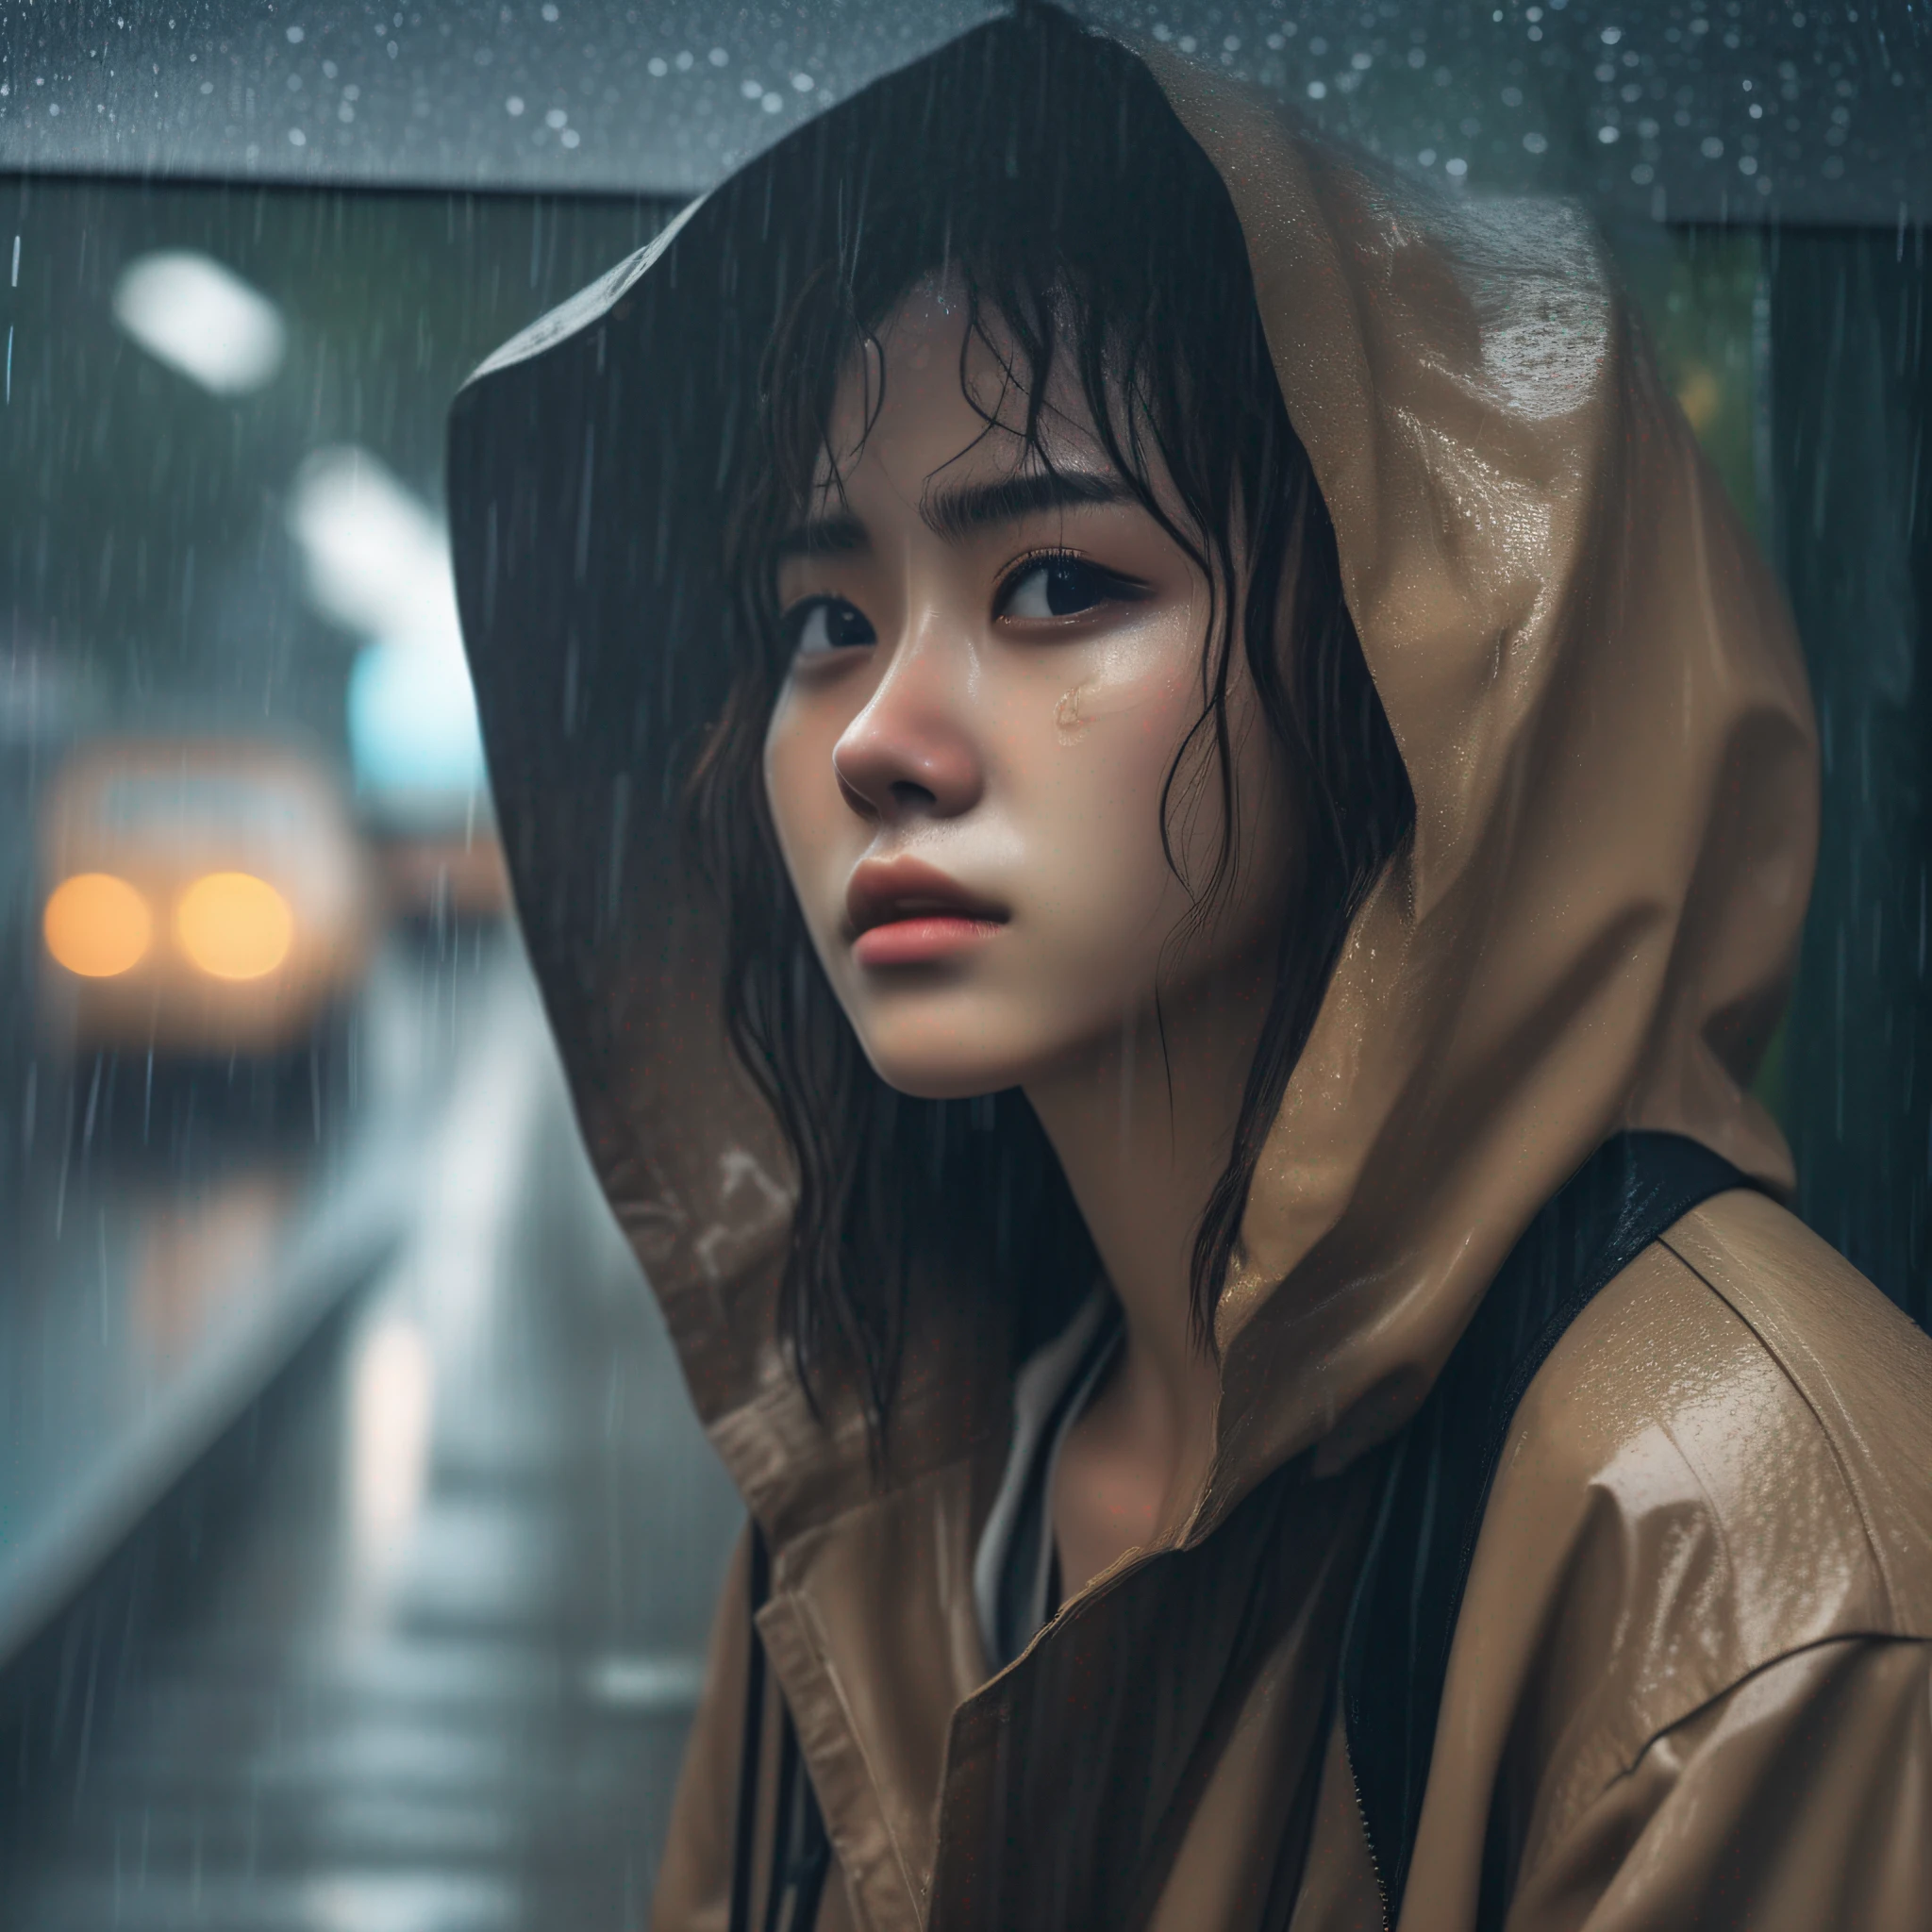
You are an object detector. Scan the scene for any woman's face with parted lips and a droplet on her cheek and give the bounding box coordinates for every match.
[765,288,1292,1099]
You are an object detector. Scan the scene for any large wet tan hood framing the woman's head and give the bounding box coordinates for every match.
[448,11,1816,1543]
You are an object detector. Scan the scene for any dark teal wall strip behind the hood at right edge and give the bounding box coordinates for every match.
[1766,228,1932,1324]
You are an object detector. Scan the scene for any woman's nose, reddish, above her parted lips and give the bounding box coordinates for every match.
[833,638,985,821]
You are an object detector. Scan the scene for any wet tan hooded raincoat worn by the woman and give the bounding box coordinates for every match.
[450,19,1932,1932]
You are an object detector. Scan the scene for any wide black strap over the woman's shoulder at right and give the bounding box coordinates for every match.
[1341,1132,1753,1924]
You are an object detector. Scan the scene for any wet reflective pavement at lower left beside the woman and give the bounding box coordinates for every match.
[0,944,736,1932]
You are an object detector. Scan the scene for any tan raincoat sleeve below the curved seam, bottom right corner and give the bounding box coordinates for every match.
[1507,1639,1932,1932]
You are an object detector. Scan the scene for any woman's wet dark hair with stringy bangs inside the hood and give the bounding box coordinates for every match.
[690,25,1414,1430]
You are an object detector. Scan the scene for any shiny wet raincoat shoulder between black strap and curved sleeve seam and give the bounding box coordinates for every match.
[1451,1192,1932,1803]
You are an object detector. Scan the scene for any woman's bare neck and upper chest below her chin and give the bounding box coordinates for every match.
[1025,946,1274,1594]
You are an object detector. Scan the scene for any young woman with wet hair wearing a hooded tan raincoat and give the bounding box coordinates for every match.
[450,11,1932,1932]
